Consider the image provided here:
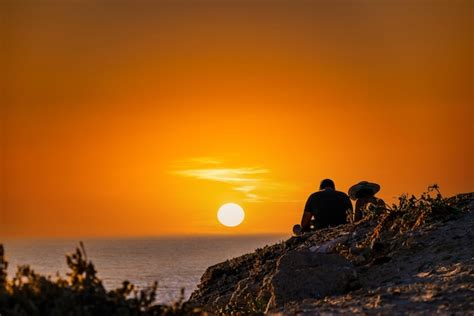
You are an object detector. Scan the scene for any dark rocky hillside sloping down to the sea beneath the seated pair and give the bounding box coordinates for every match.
[188,187,474,314]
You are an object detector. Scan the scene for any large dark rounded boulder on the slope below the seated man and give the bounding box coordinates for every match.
[267,250,357,309]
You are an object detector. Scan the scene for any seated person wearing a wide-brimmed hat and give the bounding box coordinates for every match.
[349,181,385,222]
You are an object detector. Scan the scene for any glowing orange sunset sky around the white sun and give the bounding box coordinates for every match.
[0,0,474,237]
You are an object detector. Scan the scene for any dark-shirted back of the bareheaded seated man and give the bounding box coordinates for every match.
[305,188,352,229]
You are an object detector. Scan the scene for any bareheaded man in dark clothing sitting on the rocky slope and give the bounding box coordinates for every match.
[293,179,352,235]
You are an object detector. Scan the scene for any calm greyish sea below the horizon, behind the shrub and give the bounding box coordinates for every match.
[4,235,287,302]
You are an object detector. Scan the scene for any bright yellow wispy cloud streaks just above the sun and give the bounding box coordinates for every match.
[173,157,300,202]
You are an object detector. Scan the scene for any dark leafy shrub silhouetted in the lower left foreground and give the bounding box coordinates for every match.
[0,242,199,316]
